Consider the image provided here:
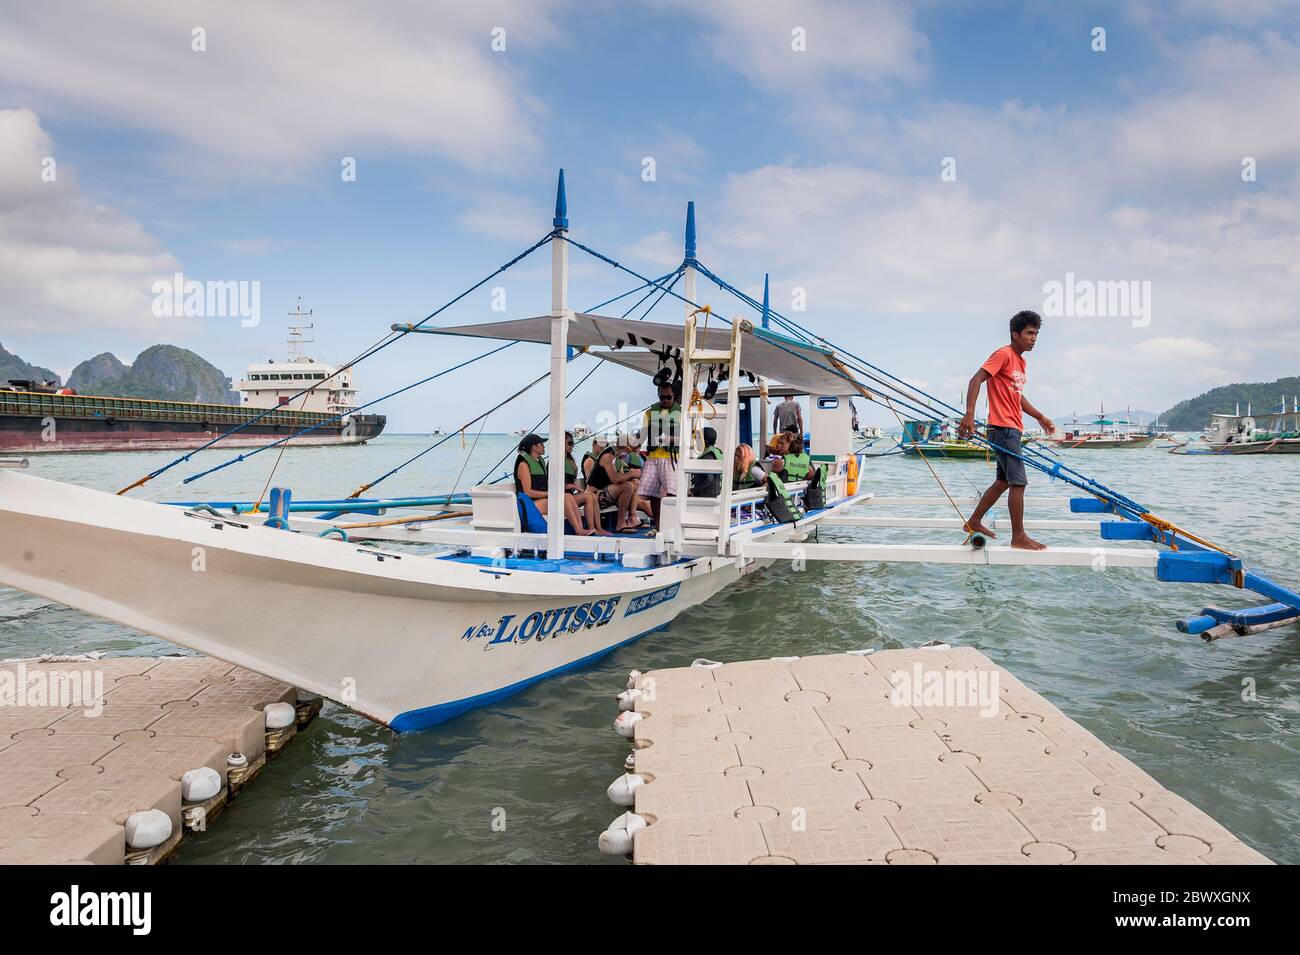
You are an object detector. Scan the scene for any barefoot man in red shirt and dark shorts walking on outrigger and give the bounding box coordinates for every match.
[958,312,1056,551]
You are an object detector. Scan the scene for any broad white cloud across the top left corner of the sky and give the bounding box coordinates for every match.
[0,0,569,178]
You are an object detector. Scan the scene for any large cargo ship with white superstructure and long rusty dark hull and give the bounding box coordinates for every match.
[0,305,387,455]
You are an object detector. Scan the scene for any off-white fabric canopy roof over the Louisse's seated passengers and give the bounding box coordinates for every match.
[421,312,855,395]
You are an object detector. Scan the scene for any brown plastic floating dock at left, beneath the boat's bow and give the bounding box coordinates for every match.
[0,656,320,865]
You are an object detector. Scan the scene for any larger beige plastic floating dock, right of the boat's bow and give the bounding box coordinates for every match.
[599,646,1270,865]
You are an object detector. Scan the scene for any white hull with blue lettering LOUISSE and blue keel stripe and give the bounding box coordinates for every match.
[0,472,785,730]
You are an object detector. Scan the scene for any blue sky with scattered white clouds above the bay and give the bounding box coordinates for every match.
[0,0,1300,433]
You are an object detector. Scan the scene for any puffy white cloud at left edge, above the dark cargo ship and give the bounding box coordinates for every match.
[0,109,177,333]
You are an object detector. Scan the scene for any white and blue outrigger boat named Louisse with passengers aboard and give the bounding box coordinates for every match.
[0,173,1300,730]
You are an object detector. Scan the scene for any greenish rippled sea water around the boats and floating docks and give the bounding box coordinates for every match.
[0,435,1300,863]
